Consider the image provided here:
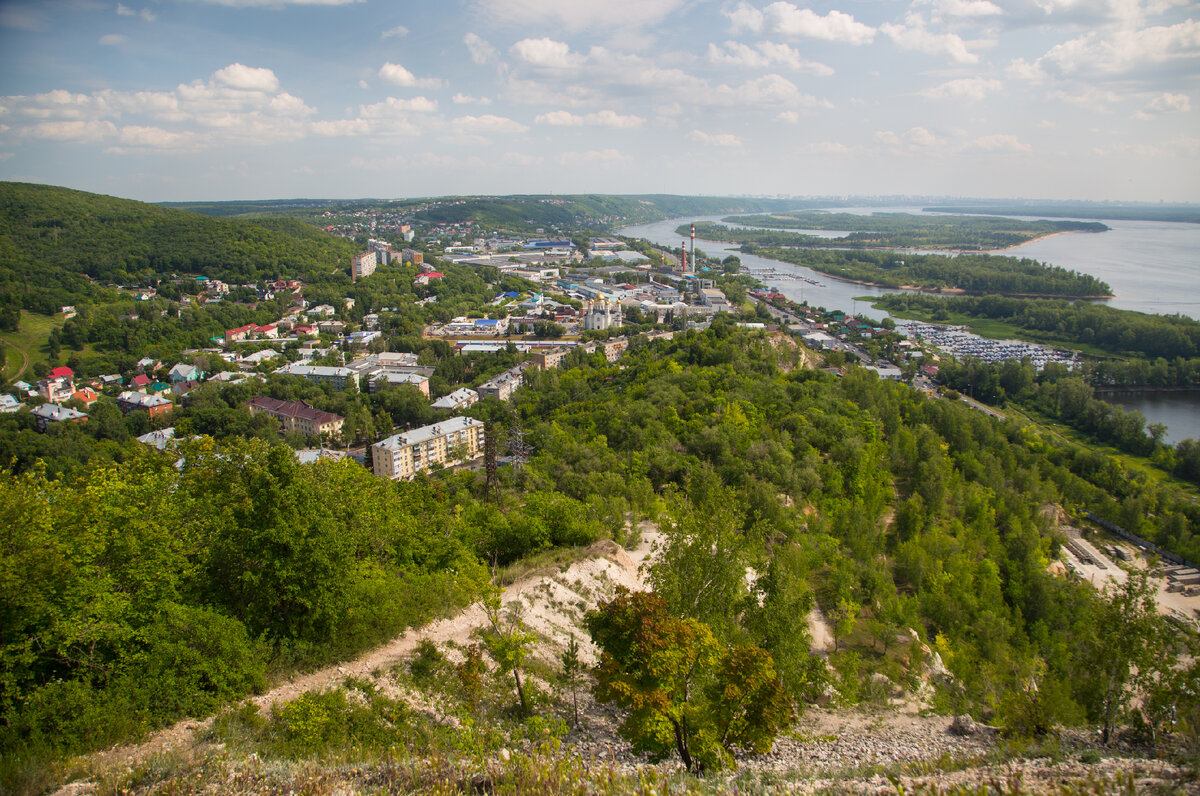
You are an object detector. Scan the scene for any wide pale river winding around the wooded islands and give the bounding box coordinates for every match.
[618,207,1200,442]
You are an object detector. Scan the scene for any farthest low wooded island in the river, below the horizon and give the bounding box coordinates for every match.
[697,210,1109,251]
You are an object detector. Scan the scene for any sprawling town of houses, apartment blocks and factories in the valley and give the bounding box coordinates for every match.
[0,225,1089,479]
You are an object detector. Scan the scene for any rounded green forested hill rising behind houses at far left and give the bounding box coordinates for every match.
[0,182,355,312]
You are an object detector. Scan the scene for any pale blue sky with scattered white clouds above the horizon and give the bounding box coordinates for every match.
[0,0,1200,202]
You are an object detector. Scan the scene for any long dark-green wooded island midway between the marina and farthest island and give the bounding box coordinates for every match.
[742,245,1112,298]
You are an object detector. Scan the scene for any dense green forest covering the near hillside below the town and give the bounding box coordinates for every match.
[0,319,1200,792]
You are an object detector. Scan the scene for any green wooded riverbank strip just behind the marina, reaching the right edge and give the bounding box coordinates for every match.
[876,294,1200,360]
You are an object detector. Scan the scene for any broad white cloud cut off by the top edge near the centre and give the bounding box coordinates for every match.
[473,0,684,32]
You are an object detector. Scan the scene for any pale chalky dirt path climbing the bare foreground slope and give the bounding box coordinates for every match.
[68,522,659,782]
